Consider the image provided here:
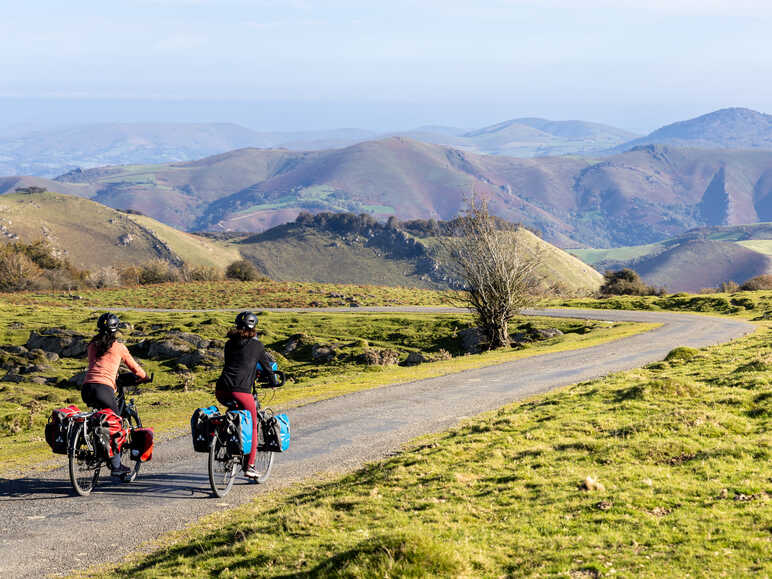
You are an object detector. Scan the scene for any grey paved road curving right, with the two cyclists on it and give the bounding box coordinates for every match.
[0,310,753,577]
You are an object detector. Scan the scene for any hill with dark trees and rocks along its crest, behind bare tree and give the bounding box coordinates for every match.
[237,215,602,295]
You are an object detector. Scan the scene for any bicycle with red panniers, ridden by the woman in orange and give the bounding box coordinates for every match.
[67,373,154,497]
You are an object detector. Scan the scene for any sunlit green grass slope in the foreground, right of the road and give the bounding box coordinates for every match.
[99,323,772,577]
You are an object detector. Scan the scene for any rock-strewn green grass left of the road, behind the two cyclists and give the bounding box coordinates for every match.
[0,304,651,471]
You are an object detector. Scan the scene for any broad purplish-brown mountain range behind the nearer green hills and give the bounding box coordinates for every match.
[0,137,772,247]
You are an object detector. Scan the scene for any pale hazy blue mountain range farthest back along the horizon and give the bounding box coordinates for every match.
[0,114,635,177]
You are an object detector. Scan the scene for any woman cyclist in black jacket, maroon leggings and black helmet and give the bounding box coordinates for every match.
[215,312,276,478]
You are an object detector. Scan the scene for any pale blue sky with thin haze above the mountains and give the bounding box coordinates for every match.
[0,0,772,132]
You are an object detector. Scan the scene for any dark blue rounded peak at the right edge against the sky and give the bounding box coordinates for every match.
[612,108,772,152]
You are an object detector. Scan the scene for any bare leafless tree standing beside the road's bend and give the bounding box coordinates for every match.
[446,196,542,349]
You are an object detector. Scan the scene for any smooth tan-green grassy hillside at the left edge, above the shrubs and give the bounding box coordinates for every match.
[0,192,238,270]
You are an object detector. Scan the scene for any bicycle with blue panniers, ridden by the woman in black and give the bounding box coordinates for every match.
[208,371,285,497]
